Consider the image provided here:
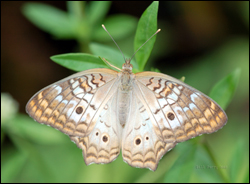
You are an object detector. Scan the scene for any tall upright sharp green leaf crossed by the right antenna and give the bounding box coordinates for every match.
[134,1,159,71]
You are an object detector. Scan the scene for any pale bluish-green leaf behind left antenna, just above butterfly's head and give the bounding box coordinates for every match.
[90,43,138,72]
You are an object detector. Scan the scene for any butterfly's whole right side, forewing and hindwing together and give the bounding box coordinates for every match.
[122,72,227,170]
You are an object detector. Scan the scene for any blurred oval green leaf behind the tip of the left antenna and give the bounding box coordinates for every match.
[92,15,137,41]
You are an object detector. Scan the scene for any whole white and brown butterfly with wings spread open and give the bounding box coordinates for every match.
[26,25,227,171]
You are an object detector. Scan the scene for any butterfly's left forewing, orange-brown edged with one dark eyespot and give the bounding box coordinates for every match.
[26,69,118,137]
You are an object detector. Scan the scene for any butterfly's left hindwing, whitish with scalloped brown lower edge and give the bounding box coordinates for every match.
[70,88,121,165]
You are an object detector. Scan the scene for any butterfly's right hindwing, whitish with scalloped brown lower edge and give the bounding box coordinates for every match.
[122,88,176,170]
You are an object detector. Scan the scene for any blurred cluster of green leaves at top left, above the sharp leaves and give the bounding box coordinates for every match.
[23,1,137,52]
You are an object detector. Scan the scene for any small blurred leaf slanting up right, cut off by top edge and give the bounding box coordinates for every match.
[86,1,111,26]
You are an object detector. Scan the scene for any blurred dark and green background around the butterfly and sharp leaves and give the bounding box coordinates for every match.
[1,1,249,182]
